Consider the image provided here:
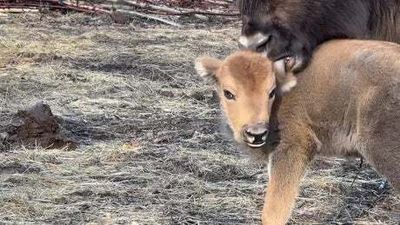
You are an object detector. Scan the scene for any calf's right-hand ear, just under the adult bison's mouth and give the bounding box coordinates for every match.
[273,57,297,93]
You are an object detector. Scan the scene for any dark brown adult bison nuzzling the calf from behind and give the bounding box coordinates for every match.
[238,0,400,72]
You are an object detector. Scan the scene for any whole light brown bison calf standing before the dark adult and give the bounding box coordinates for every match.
[196,40,400,225]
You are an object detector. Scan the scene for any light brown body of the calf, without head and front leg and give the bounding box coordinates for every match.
[278,40,400,189]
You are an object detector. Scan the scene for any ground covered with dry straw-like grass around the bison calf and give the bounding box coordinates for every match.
[0,14,400,225]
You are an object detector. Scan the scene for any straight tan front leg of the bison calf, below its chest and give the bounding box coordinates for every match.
[262,143,313,225]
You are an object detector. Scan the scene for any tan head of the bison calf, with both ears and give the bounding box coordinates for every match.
[195,51,296,148]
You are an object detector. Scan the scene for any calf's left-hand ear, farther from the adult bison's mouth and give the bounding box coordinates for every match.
[194,56,222,82]
